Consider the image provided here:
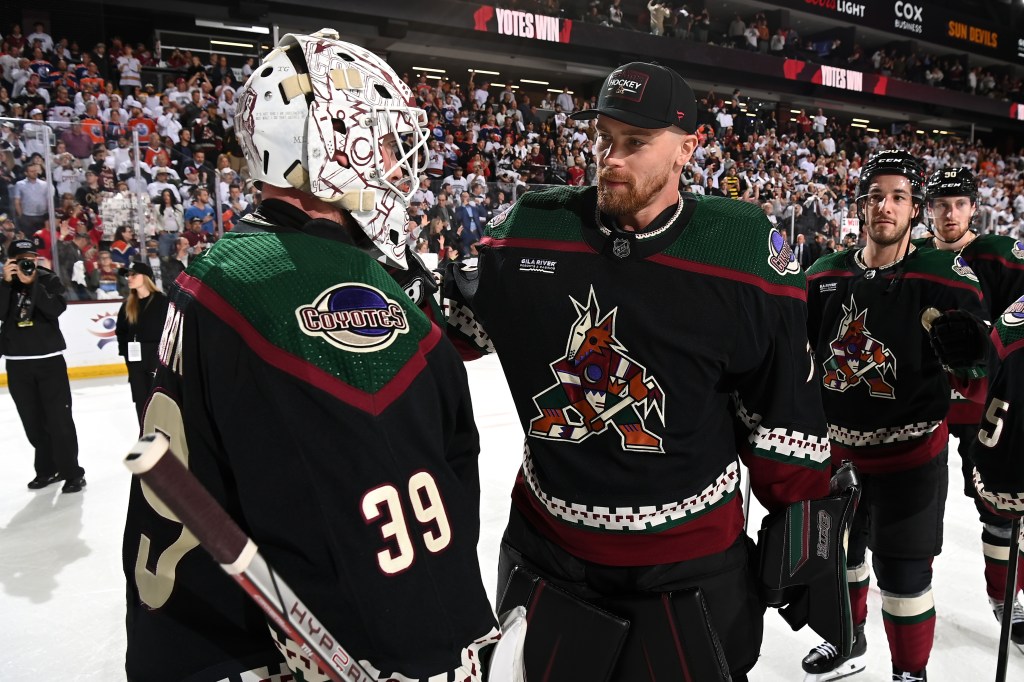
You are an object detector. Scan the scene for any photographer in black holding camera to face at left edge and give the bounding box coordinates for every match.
[0,240,85,493]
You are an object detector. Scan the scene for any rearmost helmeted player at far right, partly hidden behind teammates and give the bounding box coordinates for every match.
[923,167,1024,643]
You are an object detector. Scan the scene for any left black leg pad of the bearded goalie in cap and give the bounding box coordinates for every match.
[498,566,630,682]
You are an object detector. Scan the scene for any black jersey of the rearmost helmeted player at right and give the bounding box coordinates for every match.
[914,235,1024,425]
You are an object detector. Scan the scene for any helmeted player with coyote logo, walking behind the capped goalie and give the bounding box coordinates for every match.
[803,150,986,681]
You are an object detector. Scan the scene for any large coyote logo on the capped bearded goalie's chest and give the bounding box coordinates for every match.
[529,288,665,453]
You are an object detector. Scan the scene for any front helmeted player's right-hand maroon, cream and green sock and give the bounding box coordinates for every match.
[882,586,935,671]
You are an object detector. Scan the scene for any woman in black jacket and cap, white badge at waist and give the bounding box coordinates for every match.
[117,261,167,424]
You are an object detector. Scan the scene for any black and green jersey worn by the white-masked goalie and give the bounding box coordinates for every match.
[124,202,497,682]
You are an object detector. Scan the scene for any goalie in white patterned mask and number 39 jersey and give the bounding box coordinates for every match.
[124,30,498,682]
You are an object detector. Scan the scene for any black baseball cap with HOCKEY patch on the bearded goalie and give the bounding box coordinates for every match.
[569,61,697,132]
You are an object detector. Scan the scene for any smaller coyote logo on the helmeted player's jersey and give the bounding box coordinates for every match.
[822,299,896,398]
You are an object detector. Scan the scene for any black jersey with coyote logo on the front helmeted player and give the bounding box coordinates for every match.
[807,244,986,473]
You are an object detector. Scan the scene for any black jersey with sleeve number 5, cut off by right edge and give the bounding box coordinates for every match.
[971,295,1024,517]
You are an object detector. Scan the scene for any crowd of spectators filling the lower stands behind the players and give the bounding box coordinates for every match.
[0,17,1024,300]
